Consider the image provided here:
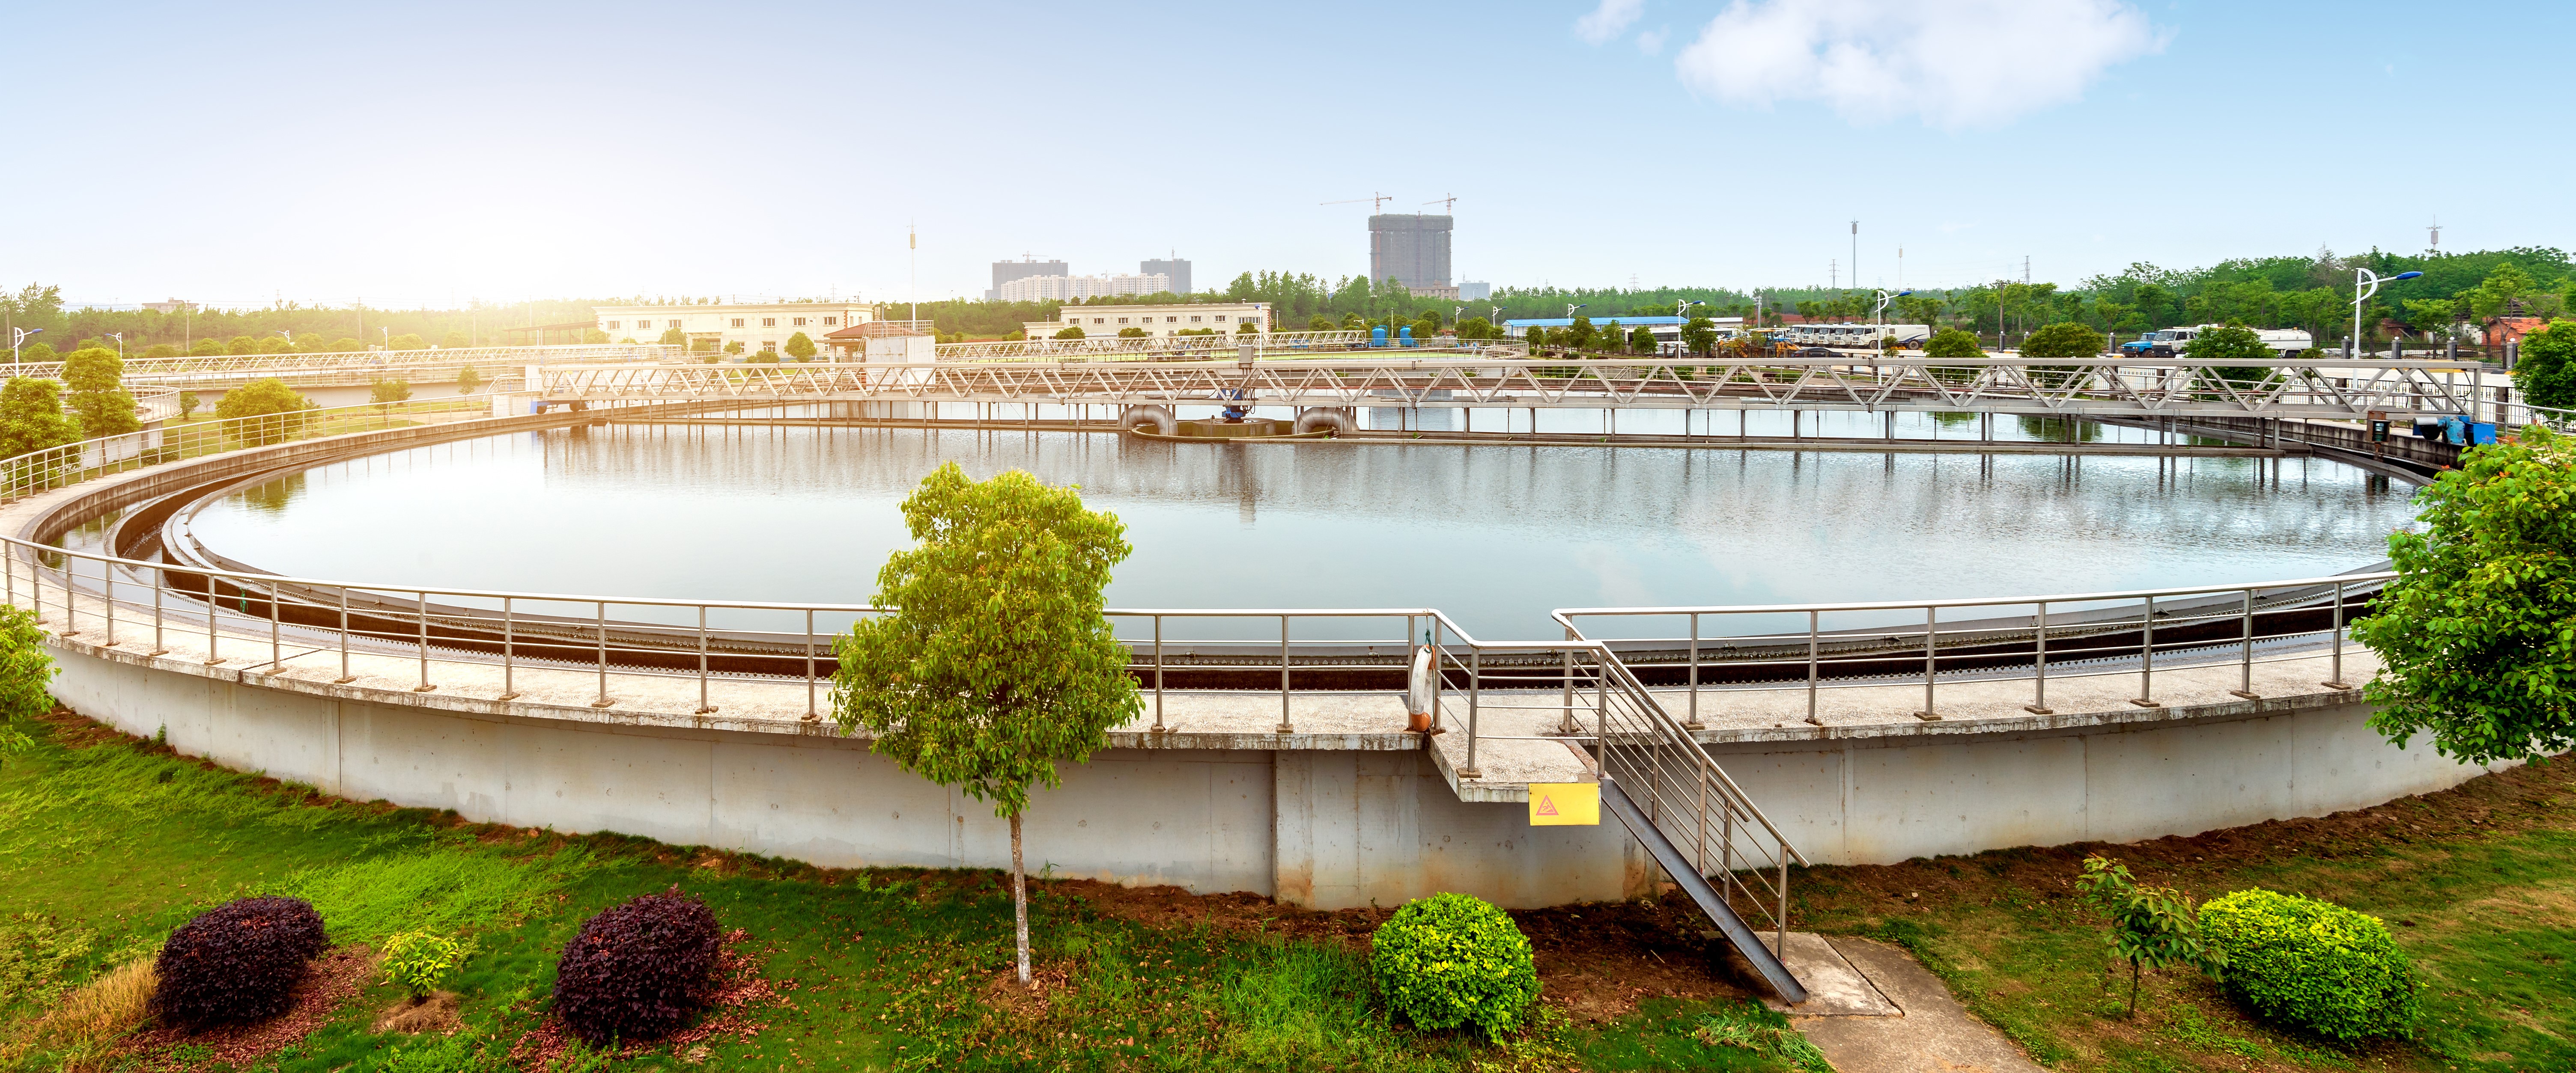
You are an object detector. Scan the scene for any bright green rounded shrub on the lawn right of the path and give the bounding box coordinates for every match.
[2200,888,2424,1042]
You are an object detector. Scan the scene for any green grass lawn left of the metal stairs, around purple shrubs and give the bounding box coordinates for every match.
[0,713,1795,1073]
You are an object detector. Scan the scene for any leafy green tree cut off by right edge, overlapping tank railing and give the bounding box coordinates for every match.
[2352,425,2576,764]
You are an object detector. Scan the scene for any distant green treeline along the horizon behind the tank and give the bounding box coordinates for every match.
[15,247,2576,353]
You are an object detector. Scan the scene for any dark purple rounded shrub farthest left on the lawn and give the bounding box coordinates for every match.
[152,898,330,1032]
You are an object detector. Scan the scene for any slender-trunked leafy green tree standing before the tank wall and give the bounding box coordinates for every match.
[832,463,1144,986]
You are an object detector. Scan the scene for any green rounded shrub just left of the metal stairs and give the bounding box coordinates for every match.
[1368,893,1538,1040]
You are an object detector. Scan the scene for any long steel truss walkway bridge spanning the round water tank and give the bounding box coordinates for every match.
[525,348,2532,425]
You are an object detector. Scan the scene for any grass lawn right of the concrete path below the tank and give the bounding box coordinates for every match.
[1793,759,2576,1073]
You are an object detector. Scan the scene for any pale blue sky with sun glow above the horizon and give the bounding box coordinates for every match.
[0,0,2576,306]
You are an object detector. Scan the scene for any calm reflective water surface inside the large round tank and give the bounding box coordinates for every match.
[196,427,2409,638]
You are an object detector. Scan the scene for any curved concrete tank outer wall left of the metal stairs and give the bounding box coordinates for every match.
[54,643,1649,908]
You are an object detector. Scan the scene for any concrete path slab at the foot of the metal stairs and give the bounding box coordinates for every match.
[1772,931,2040,1073]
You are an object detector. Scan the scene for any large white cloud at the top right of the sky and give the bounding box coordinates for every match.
[1669,0,2166,129]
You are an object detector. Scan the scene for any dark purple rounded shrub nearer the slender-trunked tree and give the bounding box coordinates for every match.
[554,885,724,1045]
